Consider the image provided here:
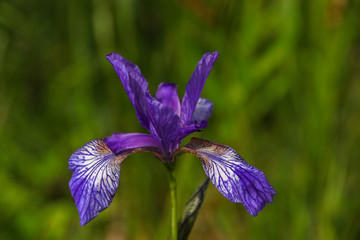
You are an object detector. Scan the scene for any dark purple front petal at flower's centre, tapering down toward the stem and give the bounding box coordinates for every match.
[147,96,180,158]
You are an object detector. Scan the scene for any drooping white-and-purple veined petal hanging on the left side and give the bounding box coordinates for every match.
[69,139,160,226]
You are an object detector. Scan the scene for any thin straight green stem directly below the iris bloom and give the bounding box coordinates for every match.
[166,163,178,240]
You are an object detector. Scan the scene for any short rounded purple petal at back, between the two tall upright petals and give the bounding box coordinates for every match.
[156,83,180,116]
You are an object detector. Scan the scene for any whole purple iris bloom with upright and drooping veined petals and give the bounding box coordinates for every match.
[69,52,276,226]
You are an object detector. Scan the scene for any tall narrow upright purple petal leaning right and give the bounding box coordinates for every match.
[181,51,219,126]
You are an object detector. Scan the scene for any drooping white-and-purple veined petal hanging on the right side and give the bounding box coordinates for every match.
[179,138,276,216]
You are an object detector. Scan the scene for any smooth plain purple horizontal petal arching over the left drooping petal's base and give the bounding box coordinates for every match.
[104,133,161,154]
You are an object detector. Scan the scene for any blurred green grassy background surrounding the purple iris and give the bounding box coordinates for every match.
[0,0,360,240]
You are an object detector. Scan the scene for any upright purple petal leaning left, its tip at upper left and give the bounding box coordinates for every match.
[106,53,149,129]
